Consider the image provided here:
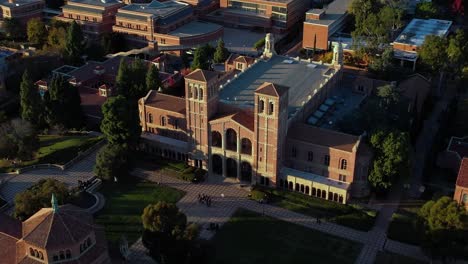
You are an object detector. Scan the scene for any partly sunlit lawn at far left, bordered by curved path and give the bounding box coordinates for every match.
[0,135,103,172]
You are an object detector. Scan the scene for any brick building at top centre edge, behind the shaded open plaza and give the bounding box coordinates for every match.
[209,0,311,34]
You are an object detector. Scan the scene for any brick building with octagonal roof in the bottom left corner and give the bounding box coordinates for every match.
[0,197,111,264]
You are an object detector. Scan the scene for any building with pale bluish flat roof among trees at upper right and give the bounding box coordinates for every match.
[392,18,452,66]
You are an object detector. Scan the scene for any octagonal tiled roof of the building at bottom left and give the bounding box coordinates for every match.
[23,204,95,250]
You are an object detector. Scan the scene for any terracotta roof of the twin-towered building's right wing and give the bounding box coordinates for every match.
[288,123,359,152]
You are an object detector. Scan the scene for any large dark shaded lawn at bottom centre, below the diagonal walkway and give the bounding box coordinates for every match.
[209,209,362,264]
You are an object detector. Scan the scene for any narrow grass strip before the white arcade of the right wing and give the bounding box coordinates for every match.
[258,189,377,231]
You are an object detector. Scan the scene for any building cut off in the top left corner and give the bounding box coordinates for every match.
[0,0,45,27]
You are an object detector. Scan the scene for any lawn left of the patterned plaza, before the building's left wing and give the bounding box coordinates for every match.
[96,178,185,246]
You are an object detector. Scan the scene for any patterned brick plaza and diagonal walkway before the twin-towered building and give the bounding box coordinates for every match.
[133,169,427,263]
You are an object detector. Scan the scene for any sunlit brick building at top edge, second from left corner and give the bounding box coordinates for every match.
[57,0,124,39]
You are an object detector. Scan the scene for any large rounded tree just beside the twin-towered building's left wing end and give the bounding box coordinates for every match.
[101,95,141,147]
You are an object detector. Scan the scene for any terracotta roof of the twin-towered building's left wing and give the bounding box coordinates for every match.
[145,90,185,114]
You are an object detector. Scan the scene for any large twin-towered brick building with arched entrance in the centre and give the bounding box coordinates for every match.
[139,35,371,203]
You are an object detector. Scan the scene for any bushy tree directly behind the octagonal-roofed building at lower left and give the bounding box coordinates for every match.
[15,178,70,221]
